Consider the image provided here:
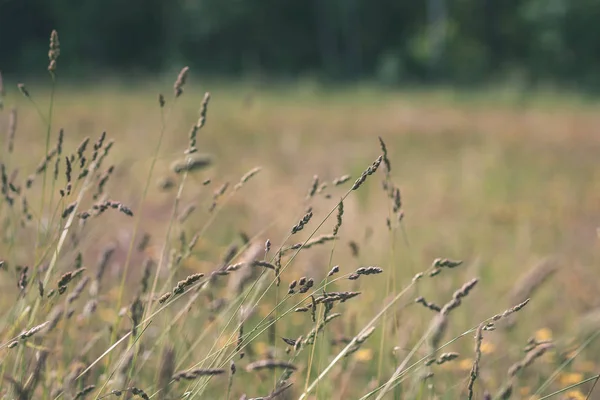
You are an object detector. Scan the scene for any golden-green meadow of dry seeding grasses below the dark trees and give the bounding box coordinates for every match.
[0,74,600,399]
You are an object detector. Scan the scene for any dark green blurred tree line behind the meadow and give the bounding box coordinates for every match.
[0,0,600,88]
